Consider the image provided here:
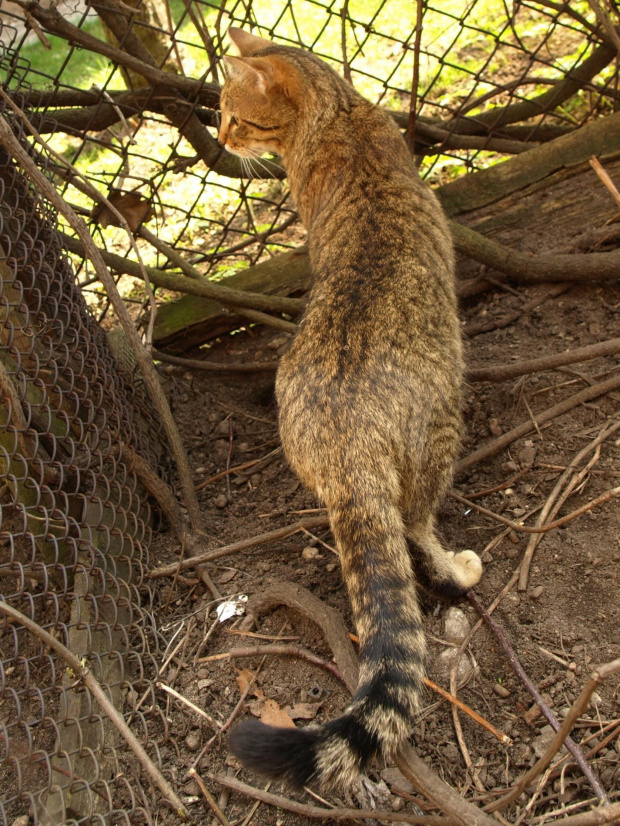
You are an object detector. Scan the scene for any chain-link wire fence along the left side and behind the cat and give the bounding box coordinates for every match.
[0,0,620,824]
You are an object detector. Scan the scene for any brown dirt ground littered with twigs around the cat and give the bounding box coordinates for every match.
[148,210,620,826]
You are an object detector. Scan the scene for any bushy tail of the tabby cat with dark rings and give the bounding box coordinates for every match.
[228,480,426,787]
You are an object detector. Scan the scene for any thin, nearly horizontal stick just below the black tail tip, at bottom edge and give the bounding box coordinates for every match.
[209,774,448,826]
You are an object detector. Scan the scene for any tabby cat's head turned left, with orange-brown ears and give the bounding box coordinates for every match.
[218,28,303,158]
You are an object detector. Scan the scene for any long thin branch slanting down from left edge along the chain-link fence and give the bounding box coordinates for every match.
[0,109,202,528]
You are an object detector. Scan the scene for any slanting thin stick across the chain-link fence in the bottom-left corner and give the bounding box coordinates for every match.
[0,601,187,820]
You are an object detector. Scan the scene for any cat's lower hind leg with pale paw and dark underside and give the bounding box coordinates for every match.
[406,517,482,597]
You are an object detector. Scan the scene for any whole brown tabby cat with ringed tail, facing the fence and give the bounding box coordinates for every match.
[219,28,482,787]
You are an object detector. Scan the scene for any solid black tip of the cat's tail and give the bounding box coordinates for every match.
[228,720,319,788]
